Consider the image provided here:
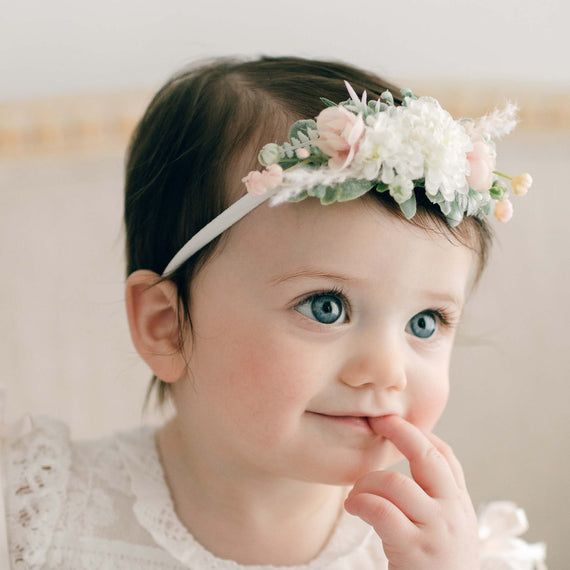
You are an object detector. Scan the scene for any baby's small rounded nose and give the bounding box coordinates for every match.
[340,331,407,392]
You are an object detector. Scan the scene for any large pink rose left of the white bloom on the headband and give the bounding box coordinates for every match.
[315,105,364,170]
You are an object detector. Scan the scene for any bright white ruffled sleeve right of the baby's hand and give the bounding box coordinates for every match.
[479,501,546,570]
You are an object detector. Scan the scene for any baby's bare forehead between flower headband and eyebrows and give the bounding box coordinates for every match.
[213,199,474,298]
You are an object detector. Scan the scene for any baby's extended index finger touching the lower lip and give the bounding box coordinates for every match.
[370,415,457,498]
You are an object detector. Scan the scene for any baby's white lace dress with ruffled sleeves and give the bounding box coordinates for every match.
[0,417,544,570]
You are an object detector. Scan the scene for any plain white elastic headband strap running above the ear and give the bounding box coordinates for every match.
[162,188,277,276]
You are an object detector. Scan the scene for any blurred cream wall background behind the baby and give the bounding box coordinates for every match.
[0,0,570,569]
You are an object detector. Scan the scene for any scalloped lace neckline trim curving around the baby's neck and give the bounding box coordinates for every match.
[117,428,372,570]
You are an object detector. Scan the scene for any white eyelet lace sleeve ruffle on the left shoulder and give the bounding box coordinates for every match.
[3,416,71,570]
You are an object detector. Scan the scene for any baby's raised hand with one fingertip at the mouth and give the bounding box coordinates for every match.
[345,416,479,570]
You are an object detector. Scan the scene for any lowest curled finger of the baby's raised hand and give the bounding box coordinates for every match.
[344,493,416,545]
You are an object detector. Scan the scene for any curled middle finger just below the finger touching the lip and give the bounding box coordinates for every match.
[348,471,433,524]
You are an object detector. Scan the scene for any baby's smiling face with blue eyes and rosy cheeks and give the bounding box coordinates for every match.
[174,199,474,484]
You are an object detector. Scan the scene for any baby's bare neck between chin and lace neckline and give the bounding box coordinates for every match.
[157,420,345,566]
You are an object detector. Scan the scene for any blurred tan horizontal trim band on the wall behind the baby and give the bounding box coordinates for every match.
[0,80,570,159]
